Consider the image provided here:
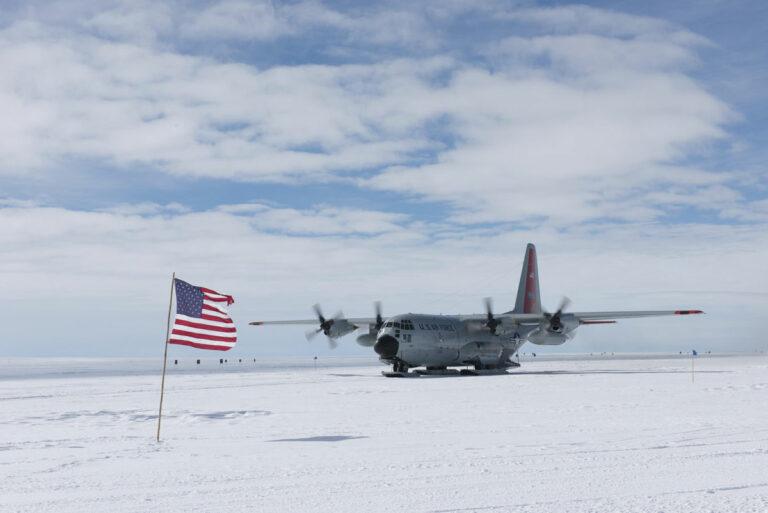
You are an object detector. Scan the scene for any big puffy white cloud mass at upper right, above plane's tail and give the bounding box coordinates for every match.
[368,8,736,224]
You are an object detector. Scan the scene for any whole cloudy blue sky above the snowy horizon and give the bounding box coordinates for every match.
[0,0,768,358]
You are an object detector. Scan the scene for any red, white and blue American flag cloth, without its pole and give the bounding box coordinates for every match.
[168,278,237,351]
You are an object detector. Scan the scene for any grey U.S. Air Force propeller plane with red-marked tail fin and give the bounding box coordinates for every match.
[250,244,704,377]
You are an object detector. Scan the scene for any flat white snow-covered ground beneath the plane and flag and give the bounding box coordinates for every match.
[0,355,768,513]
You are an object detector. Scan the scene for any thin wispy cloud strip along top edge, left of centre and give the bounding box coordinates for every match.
[40,0,444,49]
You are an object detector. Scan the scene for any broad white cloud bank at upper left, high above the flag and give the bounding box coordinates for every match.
[0,20,446,180]
